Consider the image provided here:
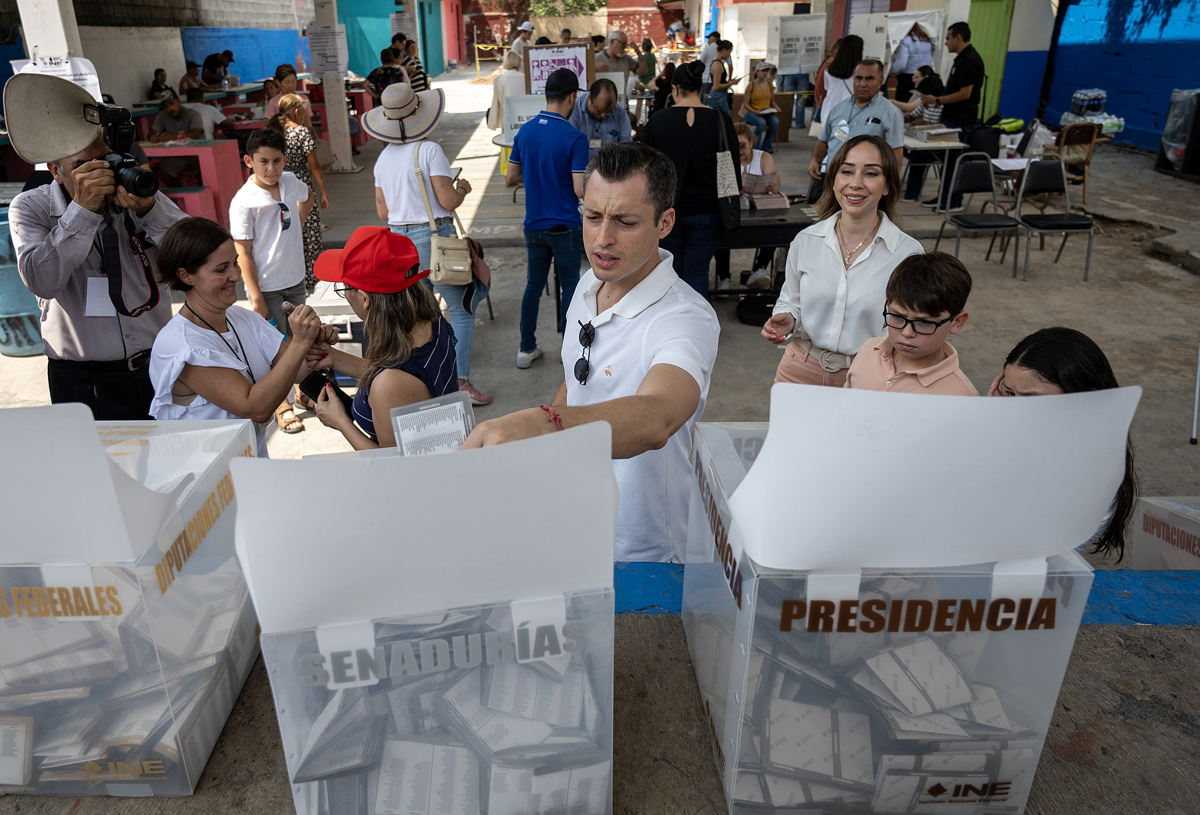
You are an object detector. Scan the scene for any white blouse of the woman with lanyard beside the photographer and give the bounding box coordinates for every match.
[150,306,283,457]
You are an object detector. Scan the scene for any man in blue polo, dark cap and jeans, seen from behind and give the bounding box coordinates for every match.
[504,68,588,368]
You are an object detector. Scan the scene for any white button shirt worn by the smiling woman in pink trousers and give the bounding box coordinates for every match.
[772,212,925,356]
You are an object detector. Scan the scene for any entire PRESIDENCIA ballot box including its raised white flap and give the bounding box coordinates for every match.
[683,385,1139,815]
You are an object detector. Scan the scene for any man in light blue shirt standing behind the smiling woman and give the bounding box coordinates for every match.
[809,59,904,202]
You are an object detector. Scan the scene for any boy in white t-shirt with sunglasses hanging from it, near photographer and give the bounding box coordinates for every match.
[229,127,312,433]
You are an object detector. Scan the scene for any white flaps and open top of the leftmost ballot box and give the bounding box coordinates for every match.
[0,403,252,564]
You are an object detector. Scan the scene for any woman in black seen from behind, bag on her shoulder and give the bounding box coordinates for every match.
[642,60,742,298]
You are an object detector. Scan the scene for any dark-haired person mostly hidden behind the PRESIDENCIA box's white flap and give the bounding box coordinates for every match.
[988,326,1138,561]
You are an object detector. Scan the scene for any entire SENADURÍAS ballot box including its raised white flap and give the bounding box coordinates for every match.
[234,424,617,815]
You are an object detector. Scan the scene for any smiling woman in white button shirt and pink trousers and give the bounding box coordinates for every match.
[762,136,924,388]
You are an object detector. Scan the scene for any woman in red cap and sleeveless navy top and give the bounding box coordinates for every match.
[308,227,458,450]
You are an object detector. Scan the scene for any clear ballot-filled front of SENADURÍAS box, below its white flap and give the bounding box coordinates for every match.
[263,589,613,815]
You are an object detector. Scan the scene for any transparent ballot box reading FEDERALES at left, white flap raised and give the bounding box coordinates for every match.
[0,404,258,796]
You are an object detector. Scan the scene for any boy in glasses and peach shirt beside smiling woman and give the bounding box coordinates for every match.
[845,252,979,396]
